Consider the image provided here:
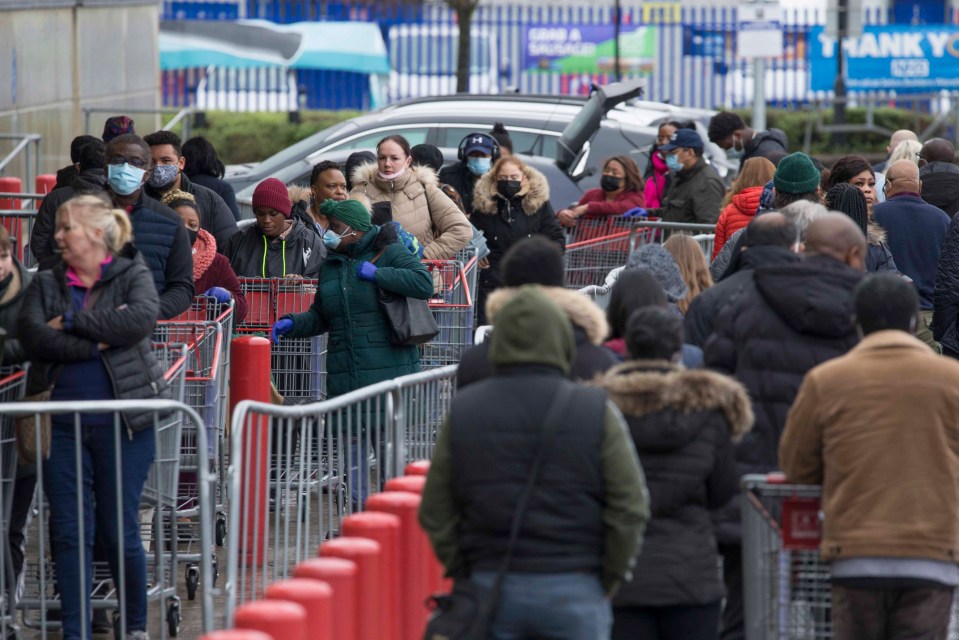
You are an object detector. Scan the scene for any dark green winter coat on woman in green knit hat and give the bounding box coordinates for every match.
[285,226,433,398]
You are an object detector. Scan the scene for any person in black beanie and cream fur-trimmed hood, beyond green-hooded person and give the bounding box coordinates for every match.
[456,236,617,389]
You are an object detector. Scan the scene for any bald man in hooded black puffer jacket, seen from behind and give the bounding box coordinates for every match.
[704,213,867,640]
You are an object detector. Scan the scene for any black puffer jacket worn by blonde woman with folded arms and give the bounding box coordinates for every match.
[17,256,169,431]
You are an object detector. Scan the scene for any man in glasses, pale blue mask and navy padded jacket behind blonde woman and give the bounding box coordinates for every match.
[106,133,193,320]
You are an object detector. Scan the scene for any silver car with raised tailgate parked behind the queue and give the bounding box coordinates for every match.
[226,80,657,200]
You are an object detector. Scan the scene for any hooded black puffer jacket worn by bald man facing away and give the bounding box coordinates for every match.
[704,256,862,543]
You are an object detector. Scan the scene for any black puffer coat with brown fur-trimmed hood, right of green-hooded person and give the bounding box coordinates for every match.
[599,360,753,607]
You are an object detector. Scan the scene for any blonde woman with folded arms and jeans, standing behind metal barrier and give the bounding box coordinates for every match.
[17,196,168,640]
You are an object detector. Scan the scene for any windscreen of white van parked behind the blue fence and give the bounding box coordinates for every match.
[390,33,491,75]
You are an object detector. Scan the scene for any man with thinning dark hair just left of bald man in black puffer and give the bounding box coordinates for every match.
[683,211,800,348]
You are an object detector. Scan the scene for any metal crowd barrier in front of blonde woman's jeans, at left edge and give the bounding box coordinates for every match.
[0,400,216,638]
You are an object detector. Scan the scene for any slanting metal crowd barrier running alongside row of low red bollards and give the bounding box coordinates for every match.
[223,366,456,624]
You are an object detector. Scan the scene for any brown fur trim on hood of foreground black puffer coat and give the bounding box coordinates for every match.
[596,360,754,440]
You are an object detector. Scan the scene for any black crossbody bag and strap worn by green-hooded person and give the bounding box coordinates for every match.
[423,393,569,640]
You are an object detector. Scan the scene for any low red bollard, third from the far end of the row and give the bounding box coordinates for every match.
[366,491,443,640]
